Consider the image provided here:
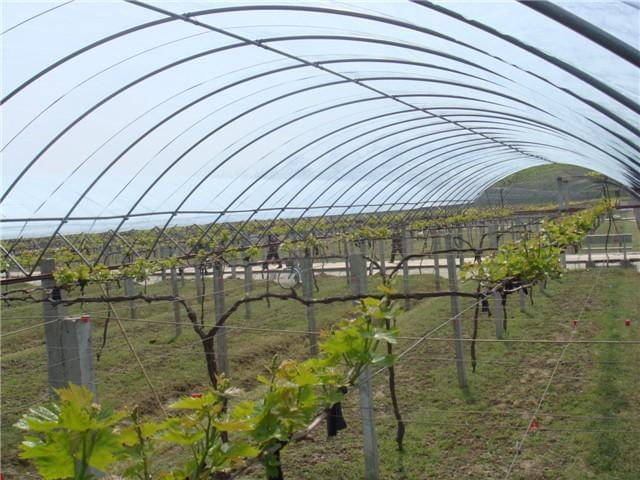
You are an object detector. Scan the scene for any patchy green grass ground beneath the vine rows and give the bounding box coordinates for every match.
[2,269,640,480]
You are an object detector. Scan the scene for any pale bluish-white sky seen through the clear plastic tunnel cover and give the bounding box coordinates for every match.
[0,0,640,238]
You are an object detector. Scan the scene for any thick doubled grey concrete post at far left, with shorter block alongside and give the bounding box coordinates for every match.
[41,259,96,396]
